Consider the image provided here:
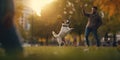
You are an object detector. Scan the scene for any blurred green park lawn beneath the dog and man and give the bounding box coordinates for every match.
[0,46,120,60]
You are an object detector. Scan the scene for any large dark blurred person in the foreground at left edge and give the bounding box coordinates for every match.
[0,0,23,56]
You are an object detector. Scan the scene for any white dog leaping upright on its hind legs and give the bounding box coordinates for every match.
[52,20,73,46]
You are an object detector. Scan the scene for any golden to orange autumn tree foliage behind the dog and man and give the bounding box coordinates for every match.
[16,0,120,39]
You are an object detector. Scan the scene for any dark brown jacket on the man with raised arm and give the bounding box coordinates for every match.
[83,10,102,29]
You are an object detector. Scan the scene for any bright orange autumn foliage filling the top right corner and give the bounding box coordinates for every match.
[94,0,120,16]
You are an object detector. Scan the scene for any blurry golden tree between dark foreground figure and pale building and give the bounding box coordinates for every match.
[14,0,26,38]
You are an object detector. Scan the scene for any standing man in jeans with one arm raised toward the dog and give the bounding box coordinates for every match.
[83,6,102,47]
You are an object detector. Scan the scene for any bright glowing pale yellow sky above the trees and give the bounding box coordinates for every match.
[23,0,57,16]
